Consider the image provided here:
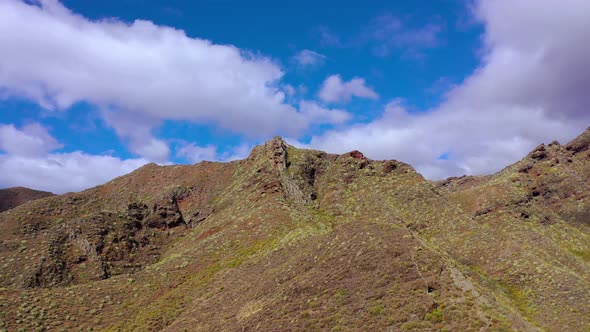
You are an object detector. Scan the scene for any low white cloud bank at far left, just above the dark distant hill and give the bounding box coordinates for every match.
[0,123,148,193]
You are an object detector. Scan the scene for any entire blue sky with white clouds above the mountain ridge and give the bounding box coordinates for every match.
[0,0,590,192]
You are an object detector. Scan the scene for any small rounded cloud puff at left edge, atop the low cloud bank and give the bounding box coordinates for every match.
[0,123,62,157]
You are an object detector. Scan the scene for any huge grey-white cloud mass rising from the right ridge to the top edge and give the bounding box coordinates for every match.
[310,0,590,179]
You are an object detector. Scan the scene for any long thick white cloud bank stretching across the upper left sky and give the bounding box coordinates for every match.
[0,0,346,152]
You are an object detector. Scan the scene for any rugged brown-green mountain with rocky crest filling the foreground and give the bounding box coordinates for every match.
[0,128,590,331]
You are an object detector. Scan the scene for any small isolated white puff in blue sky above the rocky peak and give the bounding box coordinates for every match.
[318,75,379,103]
